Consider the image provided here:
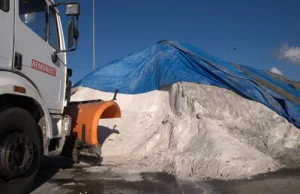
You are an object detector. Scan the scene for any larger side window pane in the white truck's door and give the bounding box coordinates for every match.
[19,0,47,41]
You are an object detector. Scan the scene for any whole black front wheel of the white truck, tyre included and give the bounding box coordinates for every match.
[0,108,42,194]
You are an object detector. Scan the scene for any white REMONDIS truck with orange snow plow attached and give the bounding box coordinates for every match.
[0,0,121,194]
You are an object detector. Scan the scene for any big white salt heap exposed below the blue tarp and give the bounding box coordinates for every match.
[72,82,300,179]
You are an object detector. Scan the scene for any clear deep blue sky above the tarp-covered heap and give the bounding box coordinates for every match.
[59,0,300,82]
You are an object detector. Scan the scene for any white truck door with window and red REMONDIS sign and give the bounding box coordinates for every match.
[13,0,66,113]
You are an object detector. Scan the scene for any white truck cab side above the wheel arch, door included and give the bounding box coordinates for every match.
[0,0,68,114]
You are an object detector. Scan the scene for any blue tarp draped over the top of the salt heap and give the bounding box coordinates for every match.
[73,41,300,128]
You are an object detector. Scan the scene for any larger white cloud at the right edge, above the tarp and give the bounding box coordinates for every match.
[279,44,300,65]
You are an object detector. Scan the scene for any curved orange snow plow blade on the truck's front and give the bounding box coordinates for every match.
[66,100,121,146]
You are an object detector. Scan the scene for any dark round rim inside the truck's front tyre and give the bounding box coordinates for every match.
[0,130,34,180]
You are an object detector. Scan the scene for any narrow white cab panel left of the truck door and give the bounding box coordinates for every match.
[0,0,14,70]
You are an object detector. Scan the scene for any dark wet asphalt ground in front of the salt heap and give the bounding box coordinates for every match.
[32,157,300,194]
